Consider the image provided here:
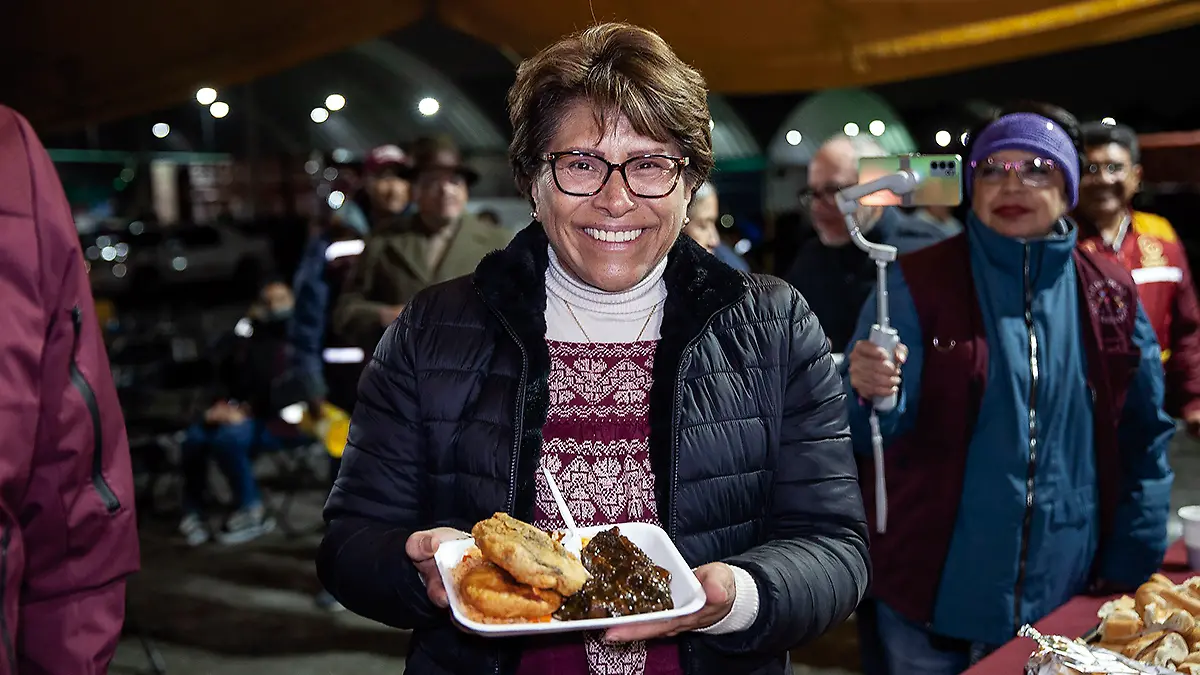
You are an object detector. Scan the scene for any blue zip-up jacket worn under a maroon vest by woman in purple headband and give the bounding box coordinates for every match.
[847,214,1175,645]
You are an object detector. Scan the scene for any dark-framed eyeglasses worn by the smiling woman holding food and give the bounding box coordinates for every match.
[541,150,691,199]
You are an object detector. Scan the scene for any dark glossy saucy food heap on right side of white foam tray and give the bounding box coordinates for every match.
[554,527,674,621]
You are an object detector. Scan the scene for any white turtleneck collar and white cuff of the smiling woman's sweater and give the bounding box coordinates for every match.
[546,243,758,635]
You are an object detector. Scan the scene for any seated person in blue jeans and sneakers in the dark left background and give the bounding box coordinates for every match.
[179,282,293,546]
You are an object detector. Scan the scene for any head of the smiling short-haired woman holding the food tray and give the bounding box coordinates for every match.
[509,24,713,292]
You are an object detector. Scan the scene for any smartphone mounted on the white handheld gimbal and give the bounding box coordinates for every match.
[858,155,962,207]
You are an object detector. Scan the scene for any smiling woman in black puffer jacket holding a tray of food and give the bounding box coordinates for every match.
[318,24,868,675]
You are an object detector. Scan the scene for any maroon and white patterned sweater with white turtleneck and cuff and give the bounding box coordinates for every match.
[518,243,758,675]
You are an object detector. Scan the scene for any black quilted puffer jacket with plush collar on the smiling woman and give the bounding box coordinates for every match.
[317,225,869,675]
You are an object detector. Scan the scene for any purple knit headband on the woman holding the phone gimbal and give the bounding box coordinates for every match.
[964,113,1079,209]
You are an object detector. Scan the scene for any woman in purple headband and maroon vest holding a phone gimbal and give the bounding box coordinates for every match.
[850,102,1175,675]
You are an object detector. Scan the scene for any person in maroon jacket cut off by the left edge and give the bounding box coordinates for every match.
[0,106,138,675]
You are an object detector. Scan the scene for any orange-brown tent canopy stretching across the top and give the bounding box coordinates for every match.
[0,0,1200,130]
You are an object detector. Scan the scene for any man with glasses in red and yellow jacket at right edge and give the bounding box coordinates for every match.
[1075,123,1200,436]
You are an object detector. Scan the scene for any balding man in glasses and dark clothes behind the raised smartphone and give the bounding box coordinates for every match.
[784,136,946,352]
